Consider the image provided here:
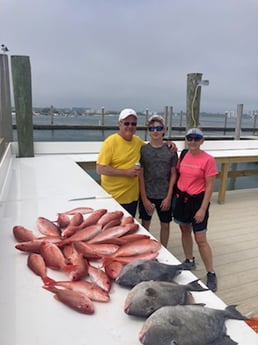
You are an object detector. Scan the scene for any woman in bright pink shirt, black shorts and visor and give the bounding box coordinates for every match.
[174,128,218,292]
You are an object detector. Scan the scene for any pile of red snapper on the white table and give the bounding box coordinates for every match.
[13,207,161,314]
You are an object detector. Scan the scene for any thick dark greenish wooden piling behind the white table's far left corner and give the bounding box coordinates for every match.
[11,55,34,157]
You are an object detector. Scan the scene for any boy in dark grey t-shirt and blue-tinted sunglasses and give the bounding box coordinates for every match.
[139,115,178,247]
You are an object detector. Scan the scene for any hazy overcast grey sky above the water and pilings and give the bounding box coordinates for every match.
[0,0,258,112]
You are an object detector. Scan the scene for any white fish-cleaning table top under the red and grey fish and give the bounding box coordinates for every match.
[0,149,258,345]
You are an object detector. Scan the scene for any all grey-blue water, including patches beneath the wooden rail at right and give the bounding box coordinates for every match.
[13,114,258,191]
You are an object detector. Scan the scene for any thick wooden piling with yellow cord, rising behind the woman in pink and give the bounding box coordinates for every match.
[186,73,202,131]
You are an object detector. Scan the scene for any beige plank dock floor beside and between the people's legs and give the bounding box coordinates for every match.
[139,188,258,315]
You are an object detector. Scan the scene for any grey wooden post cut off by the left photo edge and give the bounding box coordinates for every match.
[0,54,13,143]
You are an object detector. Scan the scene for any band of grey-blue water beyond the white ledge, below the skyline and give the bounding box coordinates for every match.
[13,113,258,141]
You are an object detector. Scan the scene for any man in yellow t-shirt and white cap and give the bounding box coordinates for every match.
[96,108,145,217]
